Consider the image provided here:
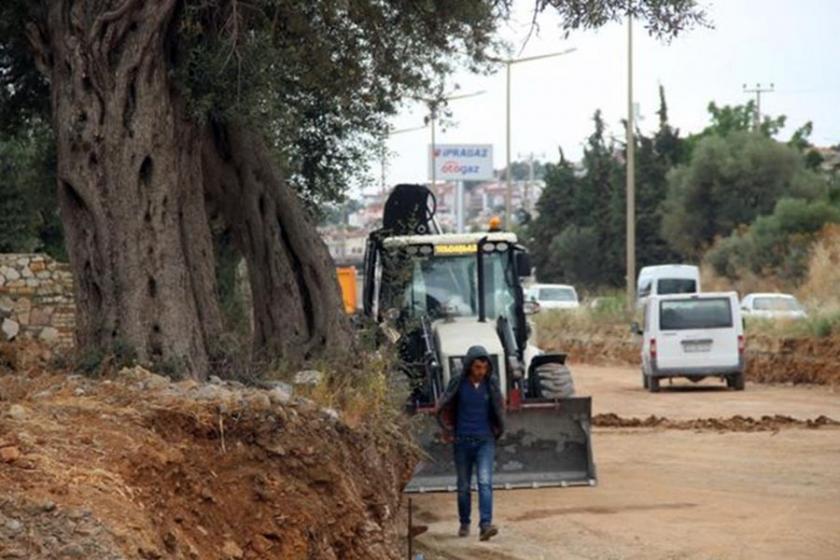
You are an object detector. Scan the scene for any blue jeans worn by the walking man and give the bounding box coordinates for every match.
[454,437,496,527]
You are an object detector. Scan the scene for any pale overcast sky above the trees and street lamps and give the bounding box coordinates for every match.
[374,0,840,190]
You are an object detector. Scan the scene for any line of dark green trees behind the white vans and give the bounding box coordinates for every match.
[525,87,840,290]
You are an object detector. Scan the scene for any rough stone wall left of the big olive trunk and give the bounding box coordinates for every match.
[0,254,76,348]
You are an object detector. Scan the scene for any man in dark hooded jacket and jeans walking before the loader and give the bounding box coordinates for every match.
[437,346,504,541]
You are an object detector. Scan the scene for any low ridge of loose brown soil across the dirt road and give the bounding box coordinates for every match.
[592,413,840,432]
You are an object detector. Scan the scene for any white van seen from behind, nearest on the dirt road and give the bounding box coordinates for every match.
[633,292,744,393]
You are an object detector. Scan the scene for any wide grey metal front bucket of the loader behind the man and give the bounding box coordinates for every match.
[405,397,597,492]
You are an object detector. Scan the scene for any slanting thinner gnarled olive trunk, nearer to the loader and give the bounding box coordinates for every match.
[203,124,352,364]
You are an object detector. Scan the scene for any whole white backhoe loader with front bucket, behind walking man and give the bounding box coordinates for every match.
[363,185,597,492]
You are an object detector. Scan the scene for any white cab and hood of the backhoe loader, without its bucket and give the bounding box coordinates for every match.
[366,232,530,406]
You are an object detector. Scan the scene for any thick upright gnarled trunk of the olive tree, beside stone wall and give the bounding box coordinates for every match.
[44,0,221,377]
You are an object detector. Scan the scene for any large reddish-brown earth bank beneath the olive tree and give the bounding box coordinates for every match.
[0,360,415,560]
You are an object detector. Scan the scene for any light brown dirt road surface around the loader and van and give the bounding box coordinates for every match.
[414,366,840,560]
